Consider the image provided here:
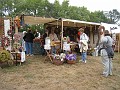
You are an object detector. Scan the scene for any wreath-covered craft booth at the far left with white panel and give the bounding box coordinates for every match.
[0,17,25,65]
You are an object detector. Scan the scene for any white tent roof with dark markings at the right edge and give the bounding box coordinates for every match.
[101,23,120,33]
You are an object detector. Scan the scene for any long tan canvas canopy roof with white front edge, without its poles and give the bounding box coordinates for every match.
[24,16,101,27]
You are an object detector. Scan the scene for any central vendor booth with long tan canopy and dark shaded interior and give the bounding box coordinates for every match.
[24,16,101,54]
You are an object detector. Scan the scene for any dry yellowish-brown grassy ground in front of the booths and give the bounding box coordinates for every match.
[0,53,120,90]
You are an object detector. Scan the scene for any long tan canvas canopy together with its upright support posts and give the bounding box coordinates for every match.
[24,16,101,47]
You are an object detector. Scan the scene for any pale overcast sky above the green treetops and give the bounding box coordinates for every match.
[49,0,120,12]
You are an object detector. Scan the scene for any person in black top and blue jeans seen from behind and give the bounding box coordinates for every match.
[23,29,35,56]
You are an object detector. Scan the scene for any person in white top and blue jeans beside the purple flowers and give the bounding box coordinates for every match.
[79,28,89,63]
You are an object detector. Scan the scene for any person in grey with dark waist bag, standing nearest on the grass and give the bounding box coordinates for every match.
[99,25,114,77]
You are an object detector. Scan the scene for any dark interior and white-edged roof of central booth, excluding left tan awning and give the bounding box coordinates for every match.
[45,18,101,52]
